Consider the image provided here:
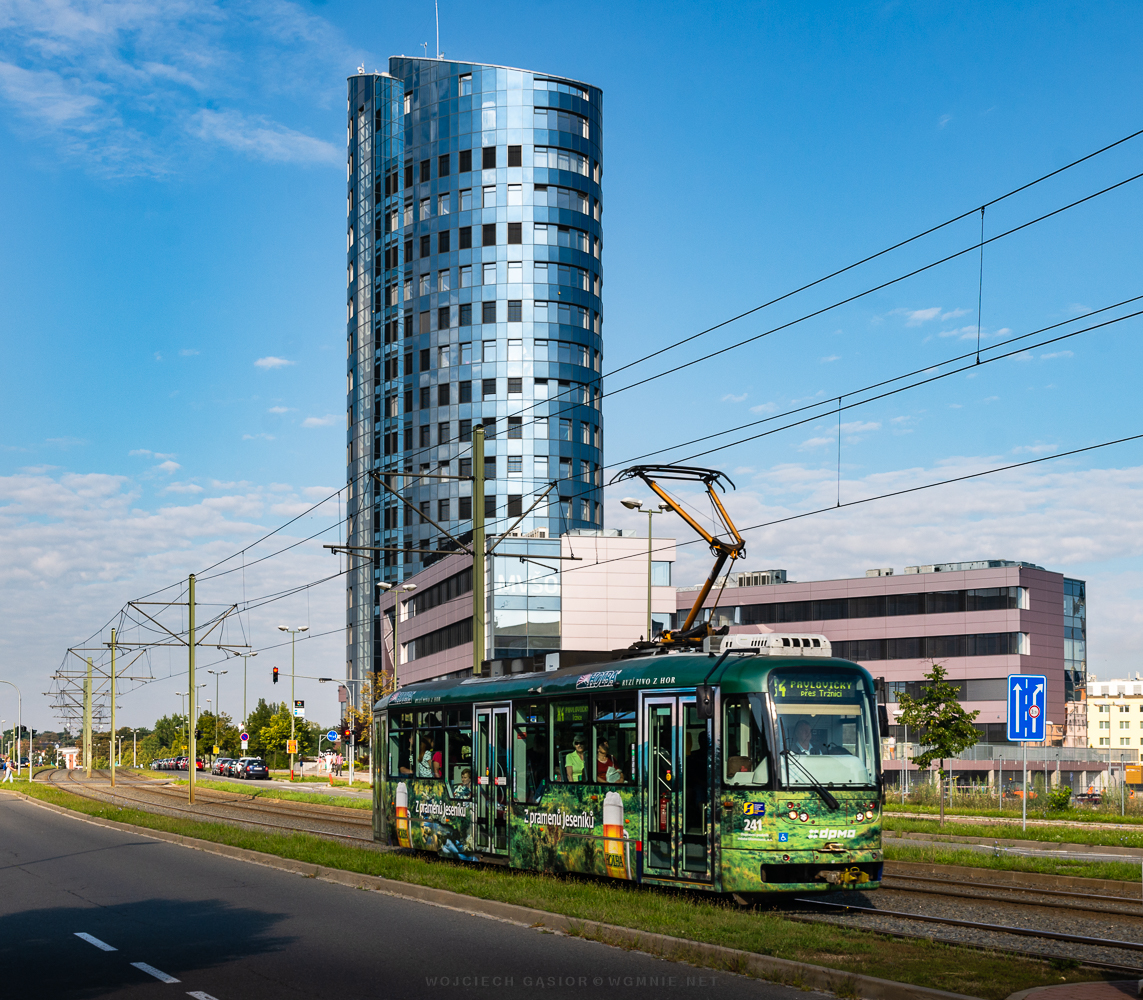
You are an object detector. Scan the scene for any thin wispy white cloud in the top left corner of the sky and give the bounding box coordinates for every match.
[0,0,360,177]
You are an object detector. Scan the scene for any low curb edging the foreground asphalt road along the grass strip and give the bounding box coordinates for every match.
[2,791,977,1000]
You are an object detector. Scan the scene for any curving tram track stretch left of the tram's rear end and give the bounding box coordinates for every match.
[47,768,374,847]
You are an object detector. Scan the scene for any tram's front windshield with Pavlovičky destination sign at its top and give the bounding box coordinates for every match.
[769,670,877,789]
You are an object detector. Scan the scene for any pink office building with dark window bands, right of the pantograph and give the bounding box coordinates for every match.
[678,560,1087,747]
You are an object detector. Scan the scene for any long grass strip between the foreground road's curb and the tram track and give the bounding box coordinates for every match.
[0,785,1108,1000]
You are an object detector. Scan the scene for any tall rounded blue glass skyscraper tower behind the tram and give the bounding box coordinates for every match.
[346,56,604,698]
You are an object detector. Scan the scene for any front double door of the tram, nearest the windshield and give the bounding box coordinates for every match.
[642,695,712,881]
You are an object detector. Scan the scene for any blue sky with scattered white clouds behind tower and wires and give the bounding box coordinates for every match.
[0,0,1143,727]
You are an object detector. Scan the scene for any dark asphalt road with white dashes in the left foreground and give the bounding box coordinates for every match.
[0,795,813,1000]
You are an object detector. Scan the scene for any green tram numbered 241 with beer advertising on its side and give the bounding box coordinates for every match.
[373,634,885,898]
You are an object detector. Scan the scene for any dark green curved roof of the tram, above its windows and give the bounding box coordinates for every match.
[374,648,873,711]
